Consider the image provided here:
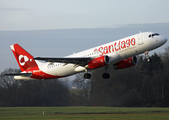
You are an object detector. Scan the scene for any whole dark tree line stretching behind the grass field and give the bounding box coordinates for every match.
[0,47,169,107]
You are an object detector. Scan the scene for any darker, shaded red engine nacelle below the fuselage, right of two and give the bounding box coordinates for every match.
[114,56,137,69]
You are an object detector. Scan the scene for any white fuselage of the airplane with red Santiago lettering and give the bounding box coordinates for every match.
[36,32,167,77]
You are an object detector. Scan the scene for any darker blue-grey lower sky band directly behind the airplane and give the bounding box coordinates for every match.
[0,23,169,72]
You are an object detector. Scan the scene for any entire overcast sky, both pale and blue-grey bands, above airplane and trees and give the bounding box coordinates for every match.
[0,0,169,72]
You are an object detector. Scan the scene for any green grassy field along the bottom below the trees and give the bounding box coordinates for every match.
[0,107,169,120]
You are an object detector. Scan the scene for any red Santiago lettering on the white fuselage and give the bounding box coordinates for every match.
[98,38,136,55]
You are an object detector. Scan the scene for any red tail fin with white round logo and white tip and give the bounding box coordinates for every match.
[10,44,39,72]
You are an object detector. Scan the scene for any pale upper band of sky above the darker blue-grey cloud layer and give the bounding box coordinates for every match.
[0,0,169,31]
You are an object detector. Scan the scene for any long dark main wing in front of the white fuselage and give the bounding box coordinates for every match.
[33,57,92,66]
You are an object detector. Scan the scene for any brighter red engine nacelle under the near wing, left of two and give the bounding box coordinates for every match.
[88,55,109,69]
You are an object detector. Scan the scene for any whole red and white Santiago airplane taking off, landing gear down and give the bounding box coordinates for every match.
[5,32,167,80]
